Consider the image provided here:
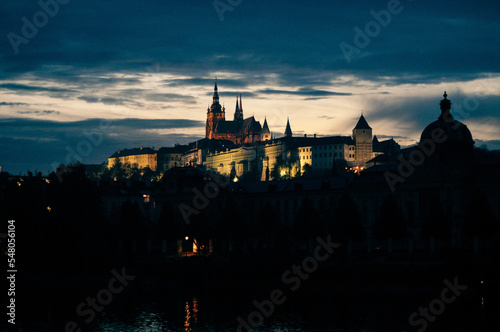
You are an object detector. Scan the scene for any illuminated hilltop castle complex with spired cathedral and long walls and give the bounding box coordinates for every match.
[108,79,399,181]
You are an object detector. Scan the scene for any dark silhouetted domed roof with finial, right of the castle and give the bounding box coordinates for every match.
[420,91,474,146]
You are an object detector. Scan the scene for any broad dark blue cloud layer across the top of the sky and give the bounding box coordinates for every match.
[0,0,500,88]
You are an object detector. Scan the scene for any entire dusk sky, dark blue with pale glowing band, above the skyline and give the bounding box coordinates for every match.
[0,0,500,174]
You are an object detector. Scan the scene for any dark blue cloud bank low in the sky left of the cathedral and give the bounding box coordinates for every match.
[0,118,205,173]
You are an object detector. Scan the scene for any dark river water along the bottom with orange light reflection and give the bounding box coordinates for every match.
[4,262,500,332]
